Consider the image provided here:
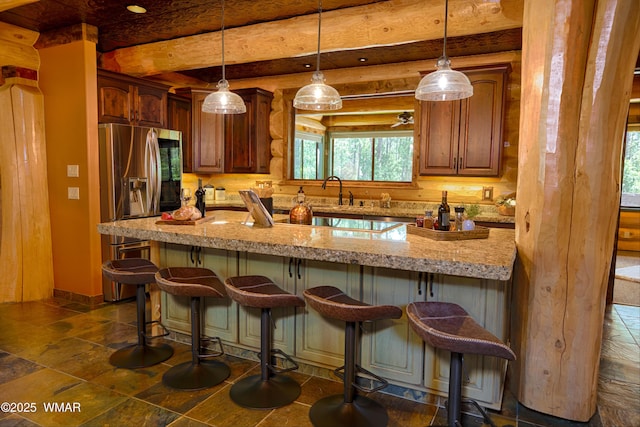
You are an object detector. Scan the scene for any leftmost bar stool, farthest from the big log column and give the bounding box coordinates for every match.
[102,258,173,369]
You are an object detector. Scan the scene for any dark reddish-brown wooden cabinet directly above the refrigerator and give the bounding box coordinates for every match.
[98,70,169,128]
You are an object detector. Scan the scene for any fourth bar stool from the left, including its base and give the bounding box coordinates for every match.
[304,286,402,427]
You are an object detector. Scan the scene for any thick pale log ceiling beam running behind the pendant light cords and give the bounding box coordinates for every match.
[100,0,523,76]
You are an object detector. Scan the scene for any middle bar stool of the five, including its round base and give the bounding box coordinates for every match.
[224,276,304,409]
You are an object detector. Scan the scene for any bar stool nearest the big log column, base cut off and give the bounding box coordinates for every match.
[407,302,516,427]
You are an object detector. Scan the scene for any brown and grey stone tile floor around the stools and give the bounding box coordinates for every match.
[0,299,640,427]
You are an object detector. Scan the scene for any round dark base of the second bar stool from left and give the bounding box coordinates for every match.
[162,360,231,390]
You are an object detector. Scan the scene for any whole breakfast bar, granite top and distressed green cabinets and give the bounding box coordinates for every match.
[98,211,516,409]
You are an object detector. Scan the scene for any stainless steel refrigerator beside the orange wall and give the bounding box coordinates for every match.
[98,123,182,302]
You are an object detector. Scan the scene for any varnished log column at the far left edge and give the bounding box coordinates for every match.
[0,66,53,303]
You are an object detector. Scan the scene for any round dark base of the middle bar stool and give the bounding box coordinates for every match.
[229,375,301,409]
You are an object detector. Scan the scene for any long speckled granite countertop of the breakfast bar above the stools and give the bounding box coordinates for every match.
[98,210,516,280]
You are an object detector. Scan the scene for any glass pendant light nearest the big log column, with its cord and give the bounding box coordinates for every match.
[416,0,473,101]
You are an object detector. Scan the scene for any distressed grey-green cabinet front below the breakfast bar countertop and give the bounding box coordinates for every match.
[160,244,510,409]
